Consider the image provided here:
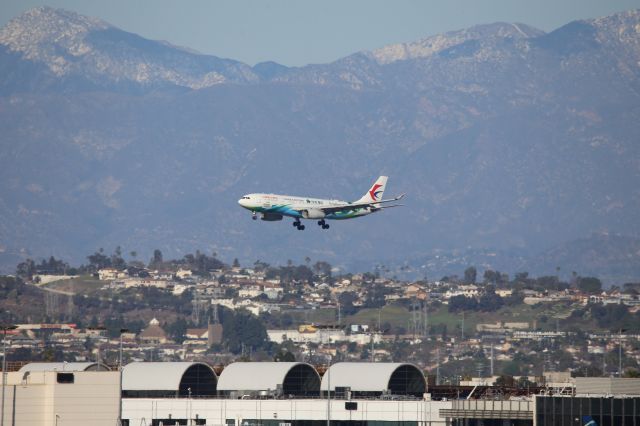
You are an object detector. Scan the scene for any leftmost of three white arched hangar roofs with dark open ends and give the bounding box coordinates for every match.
[122,362,218,395]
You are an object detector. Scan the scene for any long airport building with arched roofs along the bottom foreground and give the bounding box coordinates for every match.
[0,362,640,426]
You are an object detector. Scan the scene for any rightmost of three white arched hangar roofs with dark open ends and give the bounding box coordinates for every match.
[321,362,426,395]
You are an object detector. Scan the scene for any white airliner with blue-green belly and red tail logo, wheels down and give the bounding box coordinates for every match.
[238,176,405,231]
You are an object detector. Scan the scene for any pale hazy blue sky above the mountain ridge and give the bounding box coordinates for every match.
[0,0,640,66]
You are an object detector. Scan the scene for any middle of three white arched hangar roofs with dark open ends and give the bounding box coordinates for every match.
[218,362,320,395]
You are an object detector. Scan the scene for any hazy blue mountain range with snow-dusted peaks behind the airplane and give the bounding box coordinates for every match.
[0,8,640,278]
